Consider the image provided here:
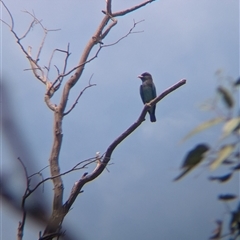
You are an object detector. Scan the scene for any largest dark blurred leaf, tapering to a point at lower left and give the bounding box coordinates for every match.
[174,144,209,181]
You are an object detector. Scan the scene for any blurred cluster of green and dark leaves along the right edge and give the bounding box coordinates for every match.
[174,73,240,239]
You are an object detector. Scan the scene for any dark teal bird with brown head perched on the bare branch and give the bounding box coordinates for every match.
[138,72,157,122]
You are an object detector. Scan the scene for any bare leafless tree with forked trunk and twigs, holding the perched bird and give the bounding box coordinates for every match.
[0,0,176,239]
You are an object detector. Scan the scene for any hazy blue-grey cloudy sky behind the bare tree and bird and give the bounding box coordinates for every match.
[0,0,239,240]
